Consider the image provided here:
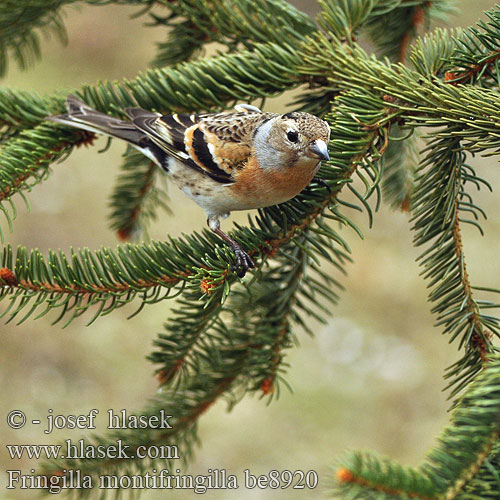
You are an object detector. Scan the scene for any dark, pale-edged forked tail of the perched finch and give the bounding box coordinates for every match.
[47,95,145,147]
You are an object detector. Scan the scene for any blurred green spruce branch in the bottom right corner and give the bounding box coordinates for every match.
[335,356,500,500]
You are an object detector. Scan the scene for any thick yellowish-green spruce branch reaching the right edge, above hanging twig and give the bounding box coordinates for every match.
[303,27,499,135]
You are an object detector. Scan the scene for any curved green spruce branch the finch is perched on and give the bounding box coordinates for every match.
[0,87,385,321]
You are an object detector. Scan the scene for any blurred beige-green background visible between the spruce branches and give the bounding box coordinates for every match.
[0,0,500,500]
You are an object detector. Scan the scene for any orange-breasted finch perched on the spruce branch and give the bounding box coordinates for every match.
[47,95,330,277]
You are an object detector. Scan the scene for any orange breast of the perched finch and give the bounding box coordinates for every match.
[230,157,318,208]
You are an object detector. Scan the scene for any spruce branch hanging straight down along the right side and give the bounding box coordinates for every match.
[413,133,500,396]
